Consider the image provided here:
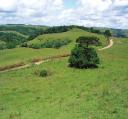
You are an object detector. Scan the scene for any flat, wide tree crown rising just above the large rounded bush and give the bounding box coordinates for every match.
[76,36,101,47]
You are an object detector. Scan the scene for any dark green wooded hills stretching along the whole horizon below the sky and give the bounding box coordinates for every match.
[0,24,128,48]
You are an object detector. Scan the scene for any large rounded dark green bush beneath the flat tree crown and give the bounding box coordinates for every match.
[69,45,99,68]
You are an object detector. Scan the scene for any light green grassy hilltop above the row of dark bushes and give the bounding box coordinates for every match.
[29,28,106,45]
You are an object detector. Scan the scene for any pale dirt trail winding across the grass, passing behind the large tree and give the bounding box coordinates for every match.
[0,39,114,73]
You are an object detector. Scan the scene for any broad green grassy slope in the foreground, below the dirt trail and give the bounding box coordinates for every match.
[0,39,128,119]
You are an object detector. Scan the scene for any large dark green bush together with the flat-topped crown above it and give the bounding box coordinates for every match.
[69,36,100,68]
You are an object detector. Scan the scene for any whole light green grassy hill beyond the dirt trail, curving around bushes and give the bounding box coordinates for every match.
[0,29,105,66]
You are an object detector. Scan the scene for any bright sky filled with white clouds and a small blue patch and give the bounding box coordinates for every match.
[0,0,128,29]
